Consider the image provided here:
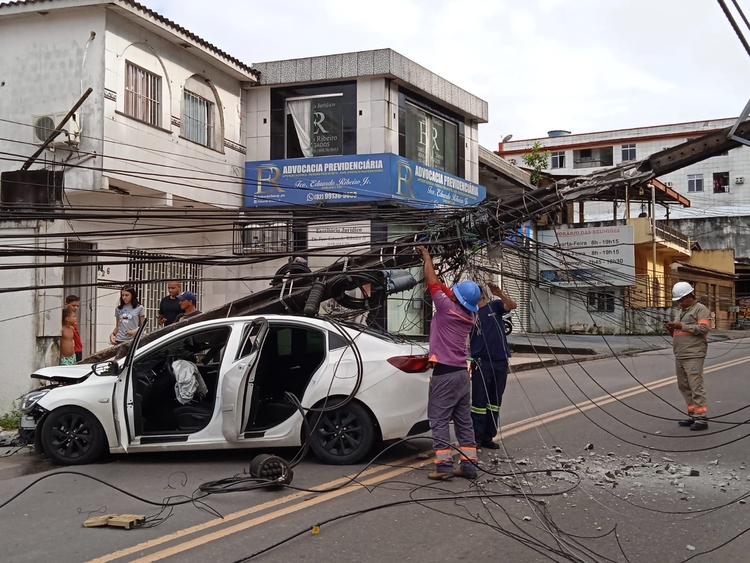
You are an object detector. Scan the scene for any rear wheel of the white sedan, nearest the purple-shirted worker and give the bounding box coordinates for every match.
[310,401,375,465]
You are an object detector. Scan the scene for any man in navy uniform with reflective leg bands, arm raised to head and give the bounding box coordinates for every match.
[471,283,518,450]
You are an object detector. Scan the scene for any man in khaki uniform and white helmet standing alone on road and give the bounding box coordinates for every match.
[666,282,711,430]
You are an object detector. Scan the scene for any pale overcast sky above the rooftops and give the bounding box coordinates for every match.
[150,0,750,150]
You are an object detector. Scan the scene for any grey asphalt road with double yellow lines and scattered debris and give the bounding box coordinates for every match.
[0,339,750,563]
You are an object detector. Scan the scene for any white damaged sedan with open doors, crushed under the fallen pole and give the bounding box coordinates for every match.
[21,315,431,465]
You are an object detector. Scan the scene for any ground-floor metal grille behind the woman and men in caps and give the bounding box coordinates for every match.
[128,249,203,331]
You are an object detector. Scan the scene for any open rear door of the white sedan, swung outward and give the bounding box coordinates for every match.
[221,317,268,442]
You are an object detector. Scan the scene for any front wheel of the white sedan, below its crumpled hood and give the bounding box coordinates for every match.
[42,407,106,465]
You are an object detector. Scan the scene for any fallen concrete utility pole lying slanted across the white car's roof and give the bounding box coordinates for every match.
[85,121,750,362]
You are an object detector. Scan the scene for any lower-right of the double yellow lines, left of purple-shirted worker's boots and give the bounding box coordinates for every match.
[131,463,419,563]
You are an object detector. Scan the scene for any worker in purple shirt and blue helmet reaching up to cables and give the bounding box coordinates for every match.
[419,246,480,481]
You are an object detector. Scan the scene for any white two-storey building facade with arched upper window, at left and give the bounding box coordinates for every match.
[0,0,264,411]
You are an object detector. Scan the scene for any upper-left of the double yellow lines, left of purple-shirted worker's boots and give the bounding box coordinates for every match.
[86,455,415,563]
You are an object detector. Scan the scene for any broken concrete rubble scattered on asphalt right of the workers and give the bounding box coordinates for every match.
[481,444,750,510]
